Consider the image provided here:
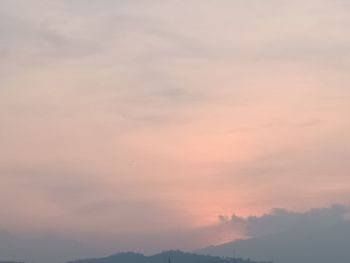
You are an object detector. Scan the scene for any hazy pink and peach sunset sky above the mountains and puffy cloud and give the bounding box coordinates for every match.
[0,0,350,253]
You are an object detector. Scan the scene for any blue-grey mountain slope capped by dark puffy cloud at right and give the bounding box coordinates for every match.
[199,205,350,263]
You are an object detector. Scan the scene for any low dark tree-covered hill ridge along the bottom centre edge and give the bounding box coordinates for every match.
[68,250,271,263]
